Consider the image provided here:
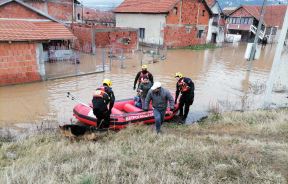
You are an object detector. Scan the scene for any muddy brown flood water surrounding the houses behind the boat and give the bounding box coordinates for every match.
[0,44,288,128]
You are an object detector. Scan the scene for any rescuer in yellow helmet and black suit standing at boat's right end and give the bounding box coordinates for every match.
[175,72,194,121]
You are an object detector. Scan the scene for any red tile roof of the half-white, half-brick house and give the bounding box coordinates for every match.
[114,0,180,13]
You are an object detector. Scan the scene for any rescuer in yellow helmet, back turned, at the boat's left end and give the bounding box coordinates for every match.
[92,79,115,129]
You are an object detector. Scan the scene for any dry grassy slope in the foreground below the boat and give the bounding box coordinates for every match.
[0,109,288,183]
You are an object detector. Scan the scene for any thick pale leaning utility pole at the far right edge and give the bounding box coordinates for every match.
[264,6,288,108]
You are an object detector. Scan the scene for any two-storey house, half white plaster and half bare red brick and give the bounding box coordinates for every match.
[114,0,212,47]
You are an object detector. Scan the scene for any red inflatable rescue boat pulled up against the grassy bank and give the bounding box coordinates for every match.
[73,99,178,129]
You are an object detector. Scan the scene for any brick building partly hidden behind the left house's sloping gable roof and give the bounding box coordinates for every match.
[22,0,81,23]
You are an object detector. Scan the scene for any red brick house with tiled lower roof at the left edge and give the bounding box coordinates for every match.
[0,0,75,86]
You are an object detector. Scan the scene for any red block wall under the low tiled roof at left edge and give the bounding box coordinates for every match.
[0,42,41,86]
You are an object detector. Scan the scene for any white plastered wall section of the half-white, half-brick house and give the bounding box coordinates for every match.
[116,13,166,44]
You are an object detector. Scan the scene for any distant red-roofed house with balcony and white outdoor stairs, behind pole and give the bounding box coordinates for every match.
[226,5,287,42]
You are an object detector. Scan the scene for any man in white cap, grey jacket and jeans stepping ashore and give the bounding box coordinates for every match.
[144,82,175,133]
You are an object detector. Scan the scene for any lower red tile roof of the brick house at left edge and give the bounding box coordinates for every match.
[0,20,75,41]
